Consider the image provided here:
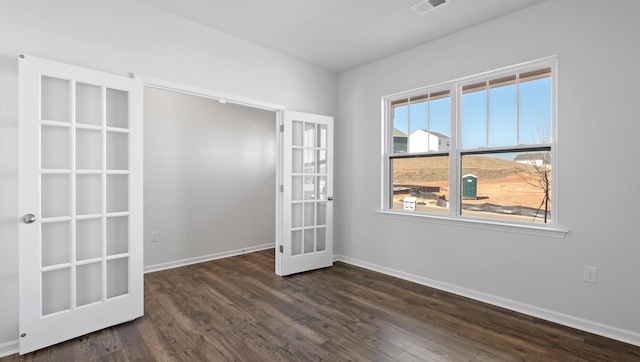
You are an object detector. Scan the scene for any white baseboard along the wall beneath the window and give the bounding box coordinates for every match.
[334,255,640,346]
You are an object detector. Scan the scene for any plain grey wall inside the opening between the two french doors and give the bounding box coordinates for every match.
[144,88,277,269]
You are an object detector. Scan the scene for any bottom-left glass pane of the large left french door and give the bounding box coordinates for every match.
[42,268,71,316]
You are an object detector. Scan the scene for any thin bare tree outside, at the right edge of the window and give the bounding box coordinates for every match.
[523,127,551,224]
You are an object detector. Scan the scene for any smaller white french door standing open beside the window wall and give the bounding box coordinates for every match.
[276,111,333,275]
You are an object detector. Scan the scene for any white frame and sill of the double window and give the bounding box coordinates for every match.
[378,56,568,238]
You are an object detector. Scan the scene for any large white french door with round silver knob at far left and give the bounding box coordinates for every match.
[18,56,143,354]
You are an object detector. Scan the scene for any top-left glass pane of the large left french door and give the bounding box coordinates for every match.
[40,76,71,122]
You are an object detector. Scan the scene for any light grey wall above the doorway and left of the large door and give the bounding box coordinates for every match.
[0,0,338,355]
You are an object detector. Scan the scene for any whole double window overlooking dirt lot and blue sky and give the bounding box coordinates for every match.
[383,59,556,225]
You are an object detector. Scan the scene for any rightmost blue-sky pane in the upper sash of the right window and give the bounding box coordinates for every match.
[519,76,552,144]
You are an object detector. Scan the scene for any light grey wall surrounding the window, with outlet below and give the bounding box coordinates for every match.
[334,0,640,345]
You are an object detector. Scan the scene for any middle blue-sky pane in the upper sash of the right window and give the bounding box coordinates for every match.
[489,75,517,147]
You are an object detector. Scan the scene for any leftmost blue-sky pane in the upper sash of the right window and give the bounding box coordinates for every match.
[460,83,487,149]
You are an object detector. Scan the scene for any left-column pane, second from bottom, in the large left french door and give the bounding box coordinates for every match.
[40,221,71,267]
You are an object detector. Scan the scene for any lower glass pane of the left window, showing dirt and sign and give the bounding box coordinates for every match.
[390,156,449,214]
